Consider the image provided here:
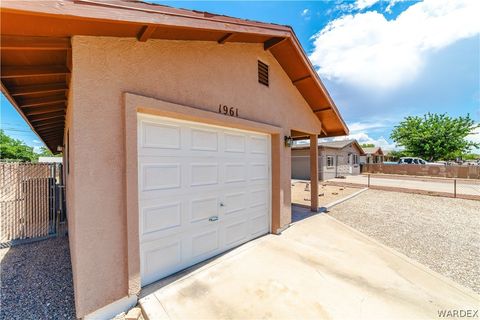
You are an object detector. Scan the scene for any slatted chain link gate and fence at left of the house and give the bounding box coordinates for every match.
[0,163,66,245]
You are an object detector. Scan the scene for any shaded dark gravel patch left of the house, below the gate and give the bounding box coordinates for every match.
[0,237,75,320]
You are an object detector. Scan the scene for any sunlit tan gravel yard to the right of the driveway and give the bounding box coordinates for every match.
[329,190,480,293]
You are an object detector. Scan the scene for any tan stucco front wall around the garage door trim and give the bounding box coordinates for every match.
[67,36,320,317]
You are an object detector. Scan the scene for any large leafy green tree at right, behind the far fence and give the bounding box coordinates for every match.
[390,113,480,161]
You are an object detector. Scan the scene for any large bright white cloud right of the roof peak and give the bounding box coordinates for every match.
[310,0,480,89]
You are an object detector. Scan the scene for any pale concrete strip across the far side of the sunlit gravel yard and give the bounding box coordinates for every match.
[328,174,480,196]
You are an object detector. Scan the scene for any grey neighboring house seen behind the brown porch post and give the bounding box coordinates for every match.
[292,140,364,180]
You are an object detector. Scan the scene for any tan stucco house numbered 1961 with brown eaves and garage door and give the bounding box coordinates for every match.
[1,0,348,319]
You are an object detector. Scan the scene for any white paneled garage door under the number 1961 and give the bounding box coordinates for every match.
[138,114,271,285]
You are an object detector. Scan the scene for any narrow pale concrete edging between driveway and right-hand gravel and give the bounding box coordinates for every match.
[323,214,480,301]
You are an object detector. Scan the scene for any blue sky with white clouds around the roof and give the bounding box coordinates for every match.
[1,0,480,151]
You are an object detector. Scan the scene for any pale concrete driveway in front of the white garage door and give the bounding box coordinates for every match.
[140,214,480,319]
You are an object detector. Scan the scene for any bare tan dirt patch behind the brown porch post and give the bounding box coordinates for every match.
[292,180,361,207]
